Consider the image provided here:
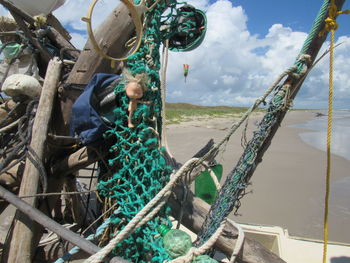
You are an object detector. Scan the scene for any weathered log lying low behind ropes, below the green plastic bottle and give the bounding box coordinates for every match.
[168,189,285,263]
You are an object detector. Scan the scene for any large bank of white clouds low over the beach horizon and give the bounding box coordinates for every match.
[164,0,350,108]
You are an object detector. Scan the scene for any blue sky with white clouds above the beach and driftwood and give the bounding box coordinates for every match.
[0,0,350,108]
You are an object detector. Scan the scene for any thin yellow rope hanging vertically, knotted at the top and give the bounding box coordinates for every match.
[323,0,350,263]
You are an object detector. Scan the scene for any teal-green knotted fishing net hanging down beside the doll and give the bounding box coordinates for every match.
[97,1,205,262]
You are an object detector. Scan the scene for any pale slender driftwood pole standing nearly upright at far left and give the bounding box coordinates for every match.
[8,58,62,263]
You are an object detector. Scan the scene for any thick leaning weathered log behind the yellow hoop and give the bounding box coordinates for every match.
[55,4,135,135]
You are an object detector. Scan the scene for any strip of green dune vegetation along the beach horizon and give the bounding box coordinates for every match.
[165,103,254,124]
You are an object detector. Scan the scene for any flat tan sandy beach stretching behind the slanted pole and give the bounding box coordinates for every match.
[167,111,350,243]
